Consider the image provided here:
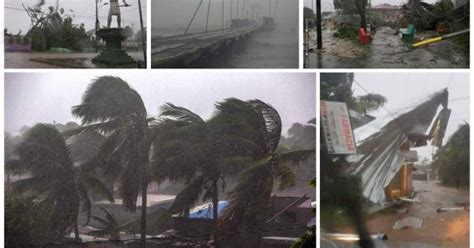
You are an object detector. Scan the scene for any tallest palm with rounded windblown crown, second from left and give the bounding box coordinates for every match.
[69,76,154,241]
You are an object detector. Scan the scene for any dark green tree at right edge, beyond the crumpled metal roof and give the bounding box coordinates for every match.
[433,123,470,188]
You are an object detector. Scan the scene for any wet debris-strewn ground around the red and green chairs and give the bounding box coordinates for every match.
[309,27,469,68]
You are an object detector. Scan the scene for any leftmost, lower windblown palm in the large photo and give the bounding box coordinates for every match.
[8,124,113,239]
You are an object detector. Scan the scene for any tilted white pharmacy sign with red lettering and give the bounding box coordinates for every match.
[320,101,356,154]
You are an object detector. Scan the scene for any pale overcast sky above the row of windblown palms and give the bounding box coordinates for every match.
[5,71,316,137]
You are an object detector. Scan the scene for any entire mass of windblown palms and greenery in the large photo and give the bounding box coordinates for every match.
[6,76,315,247]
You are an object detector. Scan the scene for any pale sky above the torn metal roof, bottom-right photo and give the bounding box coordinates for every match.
[353,73,469,159]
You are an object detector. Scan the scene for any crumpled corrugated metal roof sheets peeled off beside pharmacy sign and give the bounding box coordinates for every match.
[346,89,450,203]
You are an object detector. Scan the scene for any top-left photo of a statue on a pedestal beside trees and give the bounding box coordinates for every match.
[4,0,146,69]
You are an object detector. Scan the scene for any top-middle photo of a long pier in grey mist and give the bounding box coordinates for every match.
[151,0,299,68]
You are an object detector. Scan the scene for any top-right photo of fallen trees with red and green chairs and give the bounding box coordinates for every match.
[303,0,470,68]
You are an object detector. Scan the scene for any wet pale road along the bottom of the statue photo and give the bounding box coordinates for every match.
[5,51,143,69]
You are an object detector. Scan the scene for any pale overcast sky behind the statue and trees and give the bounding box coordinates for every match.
[5,0,147,34]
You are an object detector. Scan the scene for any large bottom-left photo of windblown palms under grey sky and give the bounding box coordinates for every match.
[4,71,316,247]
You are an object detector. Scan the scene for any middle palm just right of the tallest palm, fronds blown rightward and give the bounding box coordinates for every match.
[153,103,254,236]
